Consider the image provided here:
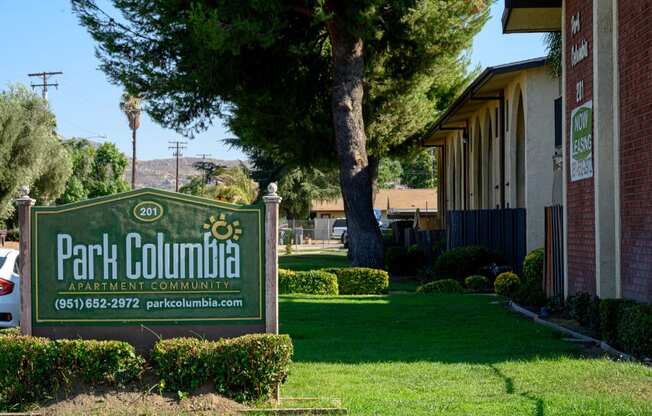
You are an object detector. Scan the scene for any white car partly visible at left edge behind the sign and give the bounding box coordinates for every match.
[0,248,20,328]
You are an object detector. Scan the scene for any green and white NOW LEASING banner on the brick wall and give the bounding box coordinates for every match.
[570,101,593,181]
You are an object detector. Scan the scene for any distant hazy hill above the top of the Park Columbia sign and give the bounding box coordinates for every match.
[125,157,247,191]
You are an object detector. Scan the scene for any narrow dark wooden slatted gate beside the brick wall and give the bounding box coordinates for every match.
[543,205,564,301]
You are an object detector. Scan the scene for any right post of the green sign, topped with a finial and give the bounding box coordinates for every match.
[263,182,282,334]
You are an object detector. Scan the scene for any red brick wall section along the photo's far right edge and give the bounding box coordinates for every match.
[618,0,652,302]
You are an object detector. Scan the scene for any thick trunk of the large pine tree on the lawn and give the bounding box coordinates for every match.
[328,16,383,268]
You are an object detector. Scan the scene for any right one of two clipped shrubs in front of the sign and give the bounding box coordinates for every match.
[152,334,293,401]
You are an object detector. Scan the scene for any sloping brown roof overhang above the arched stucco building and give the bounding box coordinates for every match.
[422,58,546,146]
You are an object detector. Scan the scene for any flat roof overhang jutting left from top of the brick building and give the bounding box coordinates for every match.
[502,0,562,33]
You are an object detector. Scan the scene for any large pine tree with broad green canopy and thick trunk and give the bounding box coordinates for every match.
[72,0,488,267]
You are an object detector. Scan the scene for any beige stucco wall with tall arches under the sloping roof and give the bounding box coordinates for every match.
[445,68,559,250]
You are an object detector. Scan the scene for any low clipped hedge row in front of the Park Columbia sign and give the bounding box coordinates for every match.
[0,331,293,412]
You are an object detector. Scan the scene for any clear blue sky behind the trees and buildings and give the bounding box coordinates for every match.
[0,0,545,159]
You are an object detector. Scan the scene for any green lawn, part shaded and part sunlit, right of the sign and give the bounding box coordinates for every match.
[280,294,652,416]
